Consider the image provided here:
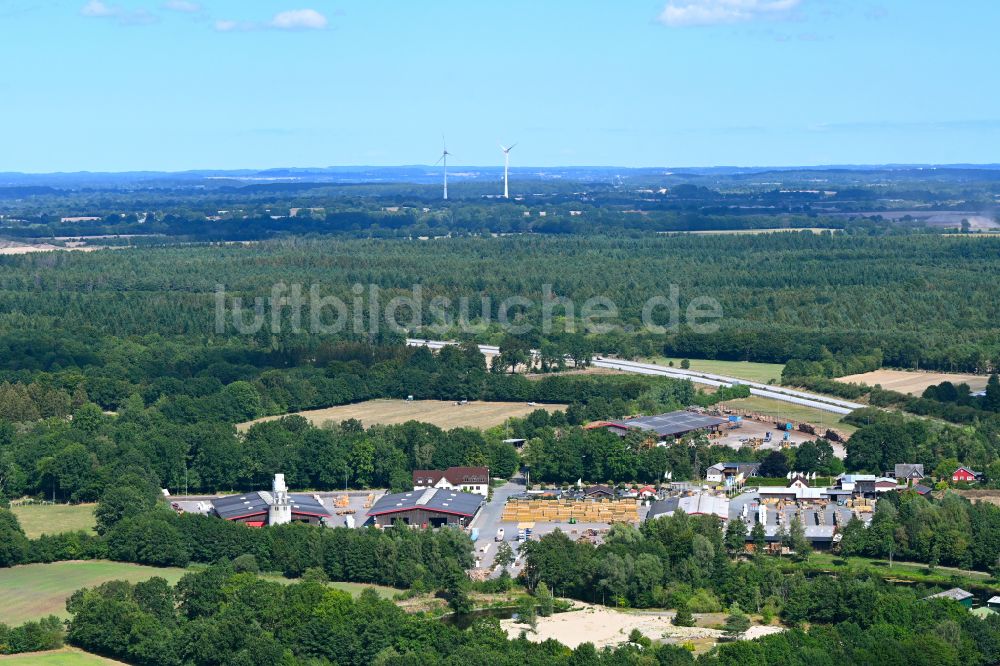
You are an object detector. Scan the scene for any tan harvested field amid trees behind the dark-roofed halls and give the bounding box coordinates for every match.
[236,400,566,432]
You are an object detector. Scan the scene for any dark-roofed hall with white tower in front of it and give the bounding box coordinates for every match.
[212,474,330,527]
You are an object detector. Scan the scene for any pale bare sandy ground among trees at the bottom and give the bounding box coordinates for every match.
[500,602,784,648]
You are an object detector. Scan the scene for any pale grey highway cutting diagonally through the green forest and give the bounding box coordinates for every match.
[406,338,864,415]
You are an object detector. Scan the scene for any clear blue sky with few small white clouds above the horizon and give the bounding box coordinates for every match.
[0,0,1000,172]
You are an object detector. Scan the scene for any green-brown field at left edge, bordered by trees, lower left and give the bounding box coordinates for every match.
[0,560,187,625]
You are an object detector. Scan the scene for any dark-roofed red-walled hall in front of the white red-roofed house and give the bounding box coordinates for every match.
[368,488,485,527]
